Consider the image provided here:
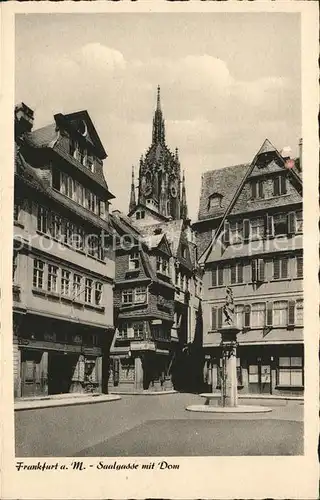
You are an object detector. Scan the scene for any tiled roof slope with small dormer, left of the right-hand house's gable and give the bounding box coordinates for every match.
[198,163,250,220]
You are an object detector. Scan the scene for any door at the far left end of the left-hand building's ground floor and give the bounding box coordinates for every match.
[21,349,42,397]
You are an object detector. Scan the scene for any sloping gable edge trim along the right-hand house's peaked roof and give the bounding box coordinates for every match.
[199,139,302,264]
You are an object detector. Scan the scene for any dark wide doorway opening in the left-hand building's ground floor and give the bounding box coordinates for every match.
[48,352,77,394]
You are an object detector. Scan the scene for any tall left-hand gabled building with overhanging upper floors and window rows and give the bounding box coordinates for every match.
[13,103,115,397]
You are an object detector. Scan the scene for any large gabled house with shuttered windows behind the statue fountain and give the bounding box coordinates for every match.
[194,140,304,394]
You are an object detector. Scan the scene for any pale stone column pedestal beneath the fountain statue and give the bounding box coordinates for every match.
[219,326,240,407]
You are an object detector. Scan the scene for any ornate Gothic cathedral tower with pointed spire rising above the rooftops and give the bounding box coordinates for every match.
[129,86,188,219]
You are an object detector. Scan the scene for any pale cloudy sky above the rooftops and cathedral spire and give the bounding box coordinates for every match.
[15,13,301,220]
